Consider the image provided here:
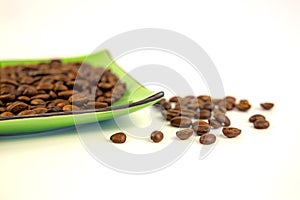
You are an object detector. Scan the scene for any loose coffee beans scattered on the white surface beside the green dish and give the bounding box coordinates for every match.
[111,95,274,145]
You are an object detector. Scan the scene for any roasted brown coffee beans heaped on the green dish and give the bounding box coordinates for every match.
[0,60,126,119]
